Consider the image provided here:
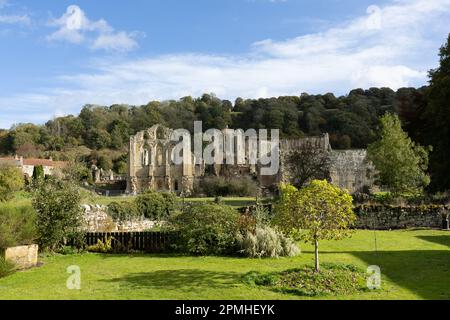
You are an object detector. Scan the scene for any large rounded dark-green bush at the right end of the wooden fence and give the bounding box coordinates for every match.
[172,203,239,255]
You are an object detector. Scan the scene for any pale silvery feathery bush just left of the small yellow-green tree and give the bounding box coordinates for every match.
[238,226,300,258]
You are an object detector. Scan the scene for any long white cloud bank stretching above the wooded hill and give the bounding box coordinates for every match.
[0,0,450,129]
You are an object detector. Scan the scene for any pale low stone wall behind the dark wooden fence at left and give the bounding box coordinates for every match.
[82,205,157,232]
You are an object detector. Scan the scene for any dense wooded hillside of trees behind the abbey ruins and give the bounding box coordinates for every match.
[0,87,427,178]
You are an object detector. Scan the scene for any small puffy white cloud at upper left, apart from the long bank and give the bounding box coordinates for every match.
[47,5,138,51]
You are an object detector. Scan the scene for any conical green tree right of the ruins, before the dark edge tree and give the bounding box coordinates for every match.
[368,113,430,194]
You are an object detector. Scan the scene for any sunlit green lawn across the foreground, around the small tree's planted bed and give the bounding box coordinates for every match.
[0,230,450,299]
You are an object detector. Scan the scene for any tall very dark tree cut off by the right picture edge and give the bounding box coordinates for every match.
[423,35,450,190]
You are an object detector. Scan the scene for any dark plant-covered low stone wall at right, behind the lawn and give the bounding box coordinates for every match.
[355,205,450,230]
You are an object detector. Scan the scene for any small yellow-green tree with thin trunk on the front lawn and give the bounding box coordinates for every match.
[275,180,356,272]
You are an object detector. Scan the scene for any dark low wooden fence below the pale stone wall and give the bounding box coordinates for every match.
[85,232,176,253]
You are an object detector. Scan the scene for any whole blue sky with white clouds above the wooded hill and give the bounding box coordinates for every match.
[0,0,450,128]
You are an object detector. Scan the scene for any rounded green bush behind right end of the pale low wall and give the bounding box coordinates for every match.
[136,191,178,220]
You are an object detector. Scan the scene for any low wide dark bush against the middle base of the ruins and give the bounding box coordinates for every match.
[195,177,258,197]
